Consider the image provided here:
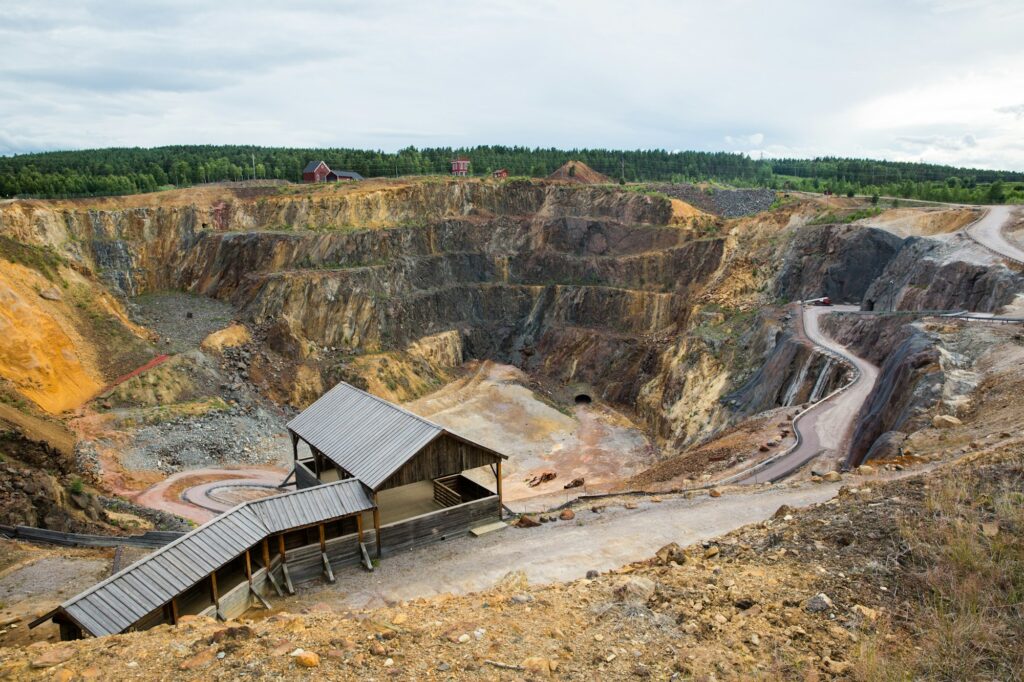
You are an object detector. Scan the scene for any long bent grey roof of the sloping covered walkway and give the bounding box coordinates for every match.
[51,479,374,637]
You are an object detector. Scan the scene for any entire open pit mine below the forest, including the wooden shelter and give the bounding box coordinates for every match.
[0,178,1024,680]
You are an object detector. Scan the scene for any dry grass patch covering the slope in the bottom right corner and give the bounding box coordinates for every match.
[858,452,1024,680]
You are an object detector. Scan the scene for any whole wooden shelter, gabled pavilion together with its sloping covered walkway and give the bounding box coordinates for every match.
[30,383,506,639]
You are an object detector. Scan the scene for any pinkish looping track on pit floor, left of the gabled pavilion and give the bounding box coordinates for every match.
[134,466,289,523]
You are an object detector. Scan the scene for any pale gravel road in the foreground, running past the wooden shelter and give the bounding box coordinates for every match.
[288,473,897,612]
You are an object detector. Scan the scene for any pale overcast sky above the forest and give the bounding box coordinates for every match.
[6,0,1024,170]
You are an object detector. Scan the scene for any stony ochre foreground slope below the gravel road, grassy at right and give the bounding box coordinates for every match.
[0,442,1024,680]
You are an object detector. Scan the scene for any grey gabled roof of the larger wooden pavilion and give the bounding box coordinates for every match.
[288,382,506,491]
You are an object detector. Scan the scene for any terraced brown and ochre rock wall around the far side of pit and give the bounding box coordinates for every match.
[0,179,1021,475]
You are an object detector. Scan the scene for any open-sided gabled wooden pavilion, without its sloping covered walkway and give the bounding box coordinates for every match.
[288,382,507,555]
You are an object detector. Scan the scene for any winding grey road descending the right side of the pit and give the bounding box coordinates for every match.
[739,305,879,483]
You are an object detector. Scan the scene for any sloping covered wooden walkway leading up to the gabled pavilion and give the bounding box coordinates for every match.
[29,480,373,640]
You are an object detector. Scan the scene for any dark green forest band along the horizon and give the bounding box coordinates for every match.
[0,145,1024,203]
